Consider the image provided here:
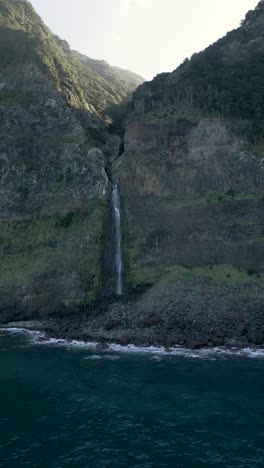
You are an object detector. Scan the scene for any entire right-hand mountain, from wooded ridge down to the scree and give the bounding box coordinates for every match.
[115,1,264,336]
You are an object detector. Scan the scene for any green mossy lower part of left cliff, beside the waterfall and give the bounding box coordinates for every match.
[0,204,105,303]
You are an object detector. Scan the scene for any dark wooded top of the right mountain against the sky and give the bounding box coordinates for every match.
[129,1,264,135]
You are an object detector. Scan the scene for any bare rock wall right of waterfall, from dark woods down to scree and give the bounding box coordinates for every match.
[116,118,264,290]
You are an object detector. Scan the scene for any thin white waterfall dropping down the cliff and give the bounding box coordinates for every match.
[112,184,123,296]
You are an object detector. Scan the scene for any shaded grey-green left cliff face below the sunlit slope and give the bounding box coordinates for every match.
[0,60,109,316]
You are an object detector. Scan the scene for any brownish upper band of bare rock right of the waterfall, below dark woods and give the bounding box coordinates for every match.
[122,118,264,199]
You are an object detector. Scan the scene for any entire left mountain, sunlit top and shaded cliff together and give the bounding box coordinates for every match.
[0,0,140,320]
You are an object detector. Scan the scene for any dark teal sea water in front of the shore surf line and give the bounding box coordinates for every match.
[0,334,264,468]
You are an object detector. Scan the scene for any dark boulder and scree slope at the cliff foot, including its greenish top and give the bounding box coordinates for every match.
[1,277,264,349]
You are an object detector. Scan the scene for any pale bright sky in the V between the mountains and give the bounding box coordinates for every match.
[31,0,258,79]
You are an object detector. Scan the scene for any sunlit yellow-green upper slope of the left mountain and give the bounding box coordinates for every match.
[0,0,143,118]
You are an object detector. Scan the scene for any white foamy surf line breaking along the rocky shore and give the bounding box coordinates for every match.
[0,327,264,360]
